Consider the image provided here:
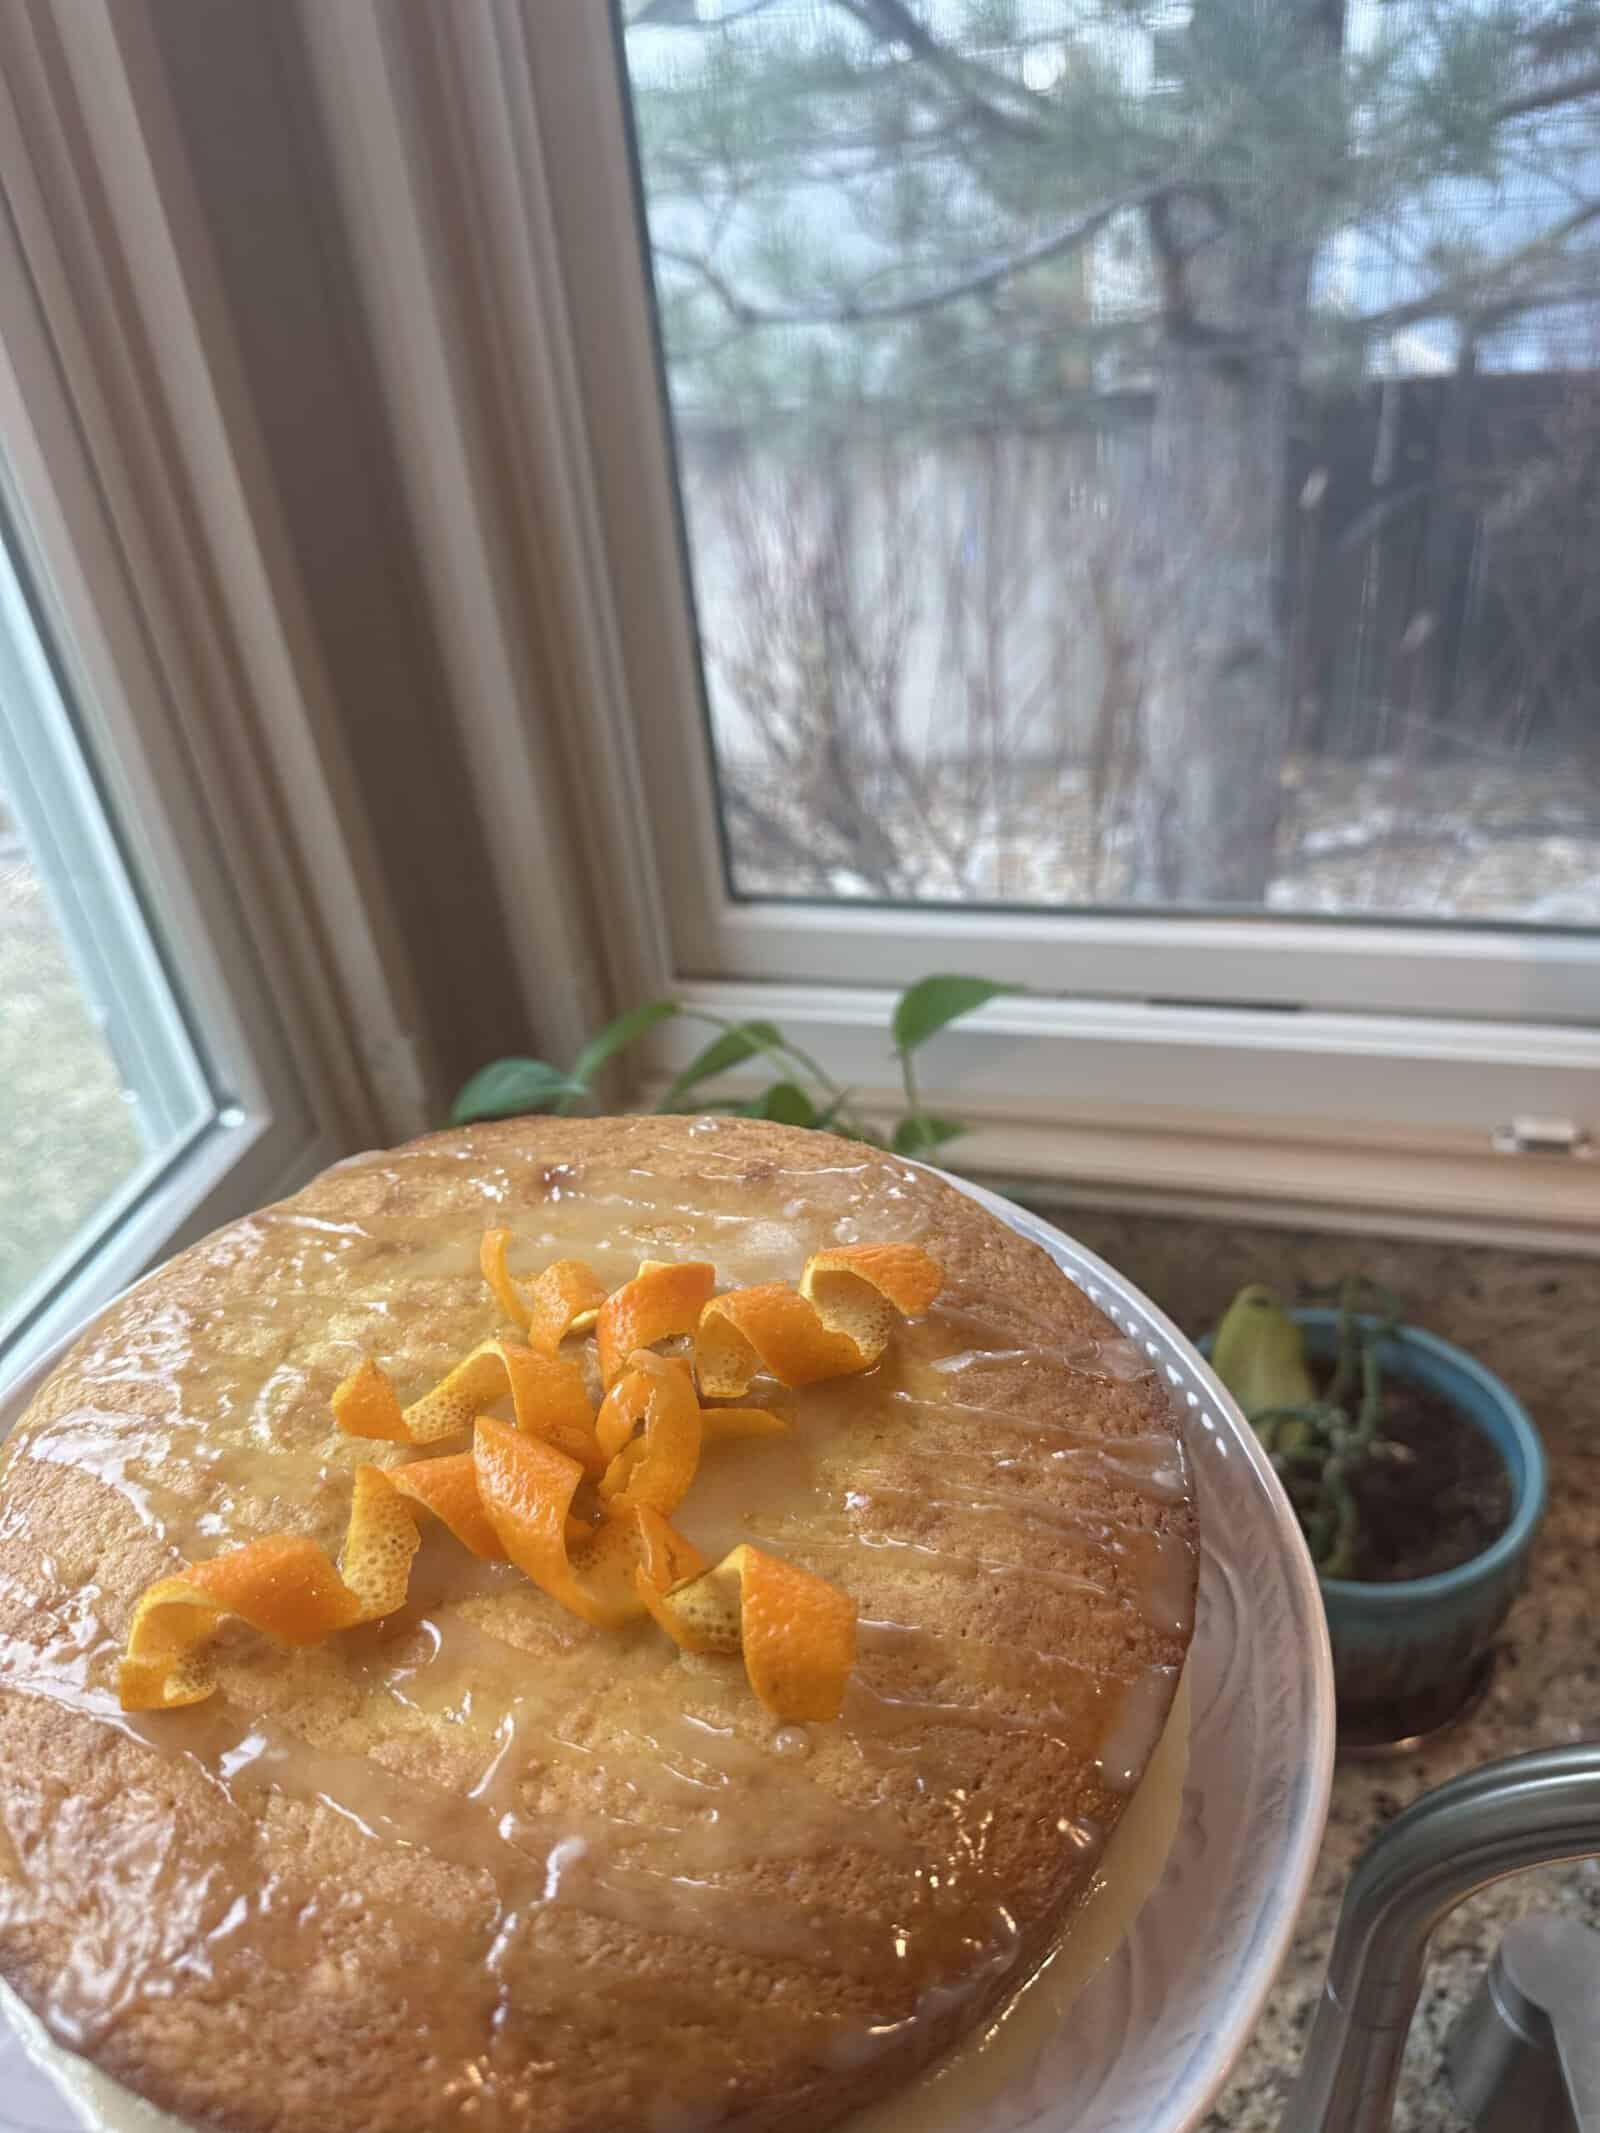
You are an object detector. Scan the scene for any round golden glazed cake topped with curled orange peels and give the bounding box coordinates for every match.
[0,1118,1197,2133]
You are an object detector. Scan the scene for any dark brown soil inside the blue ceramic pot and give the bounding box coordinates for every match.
[1322,1376,1513,1585]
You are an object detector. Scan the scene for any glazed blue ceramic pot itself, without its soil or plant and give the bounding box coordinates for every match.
[1207,1310,1545,1745]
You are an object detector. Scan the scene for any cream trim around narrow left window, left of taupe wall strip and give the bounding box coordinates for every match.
[0,0,439,1376]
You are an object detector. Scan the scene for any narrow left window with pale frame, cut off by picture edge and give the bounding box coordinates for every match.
[0,375,335,1384]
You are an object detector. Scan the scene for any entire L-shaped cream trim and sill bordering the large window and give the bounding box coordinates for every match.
[303,0,1600,1250]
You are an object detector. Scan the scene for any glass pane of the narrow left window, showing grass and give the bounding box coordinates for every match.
[0,507,215,1342]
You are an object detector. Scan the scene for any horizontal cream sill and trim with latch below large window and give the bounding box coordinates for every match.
[651,983,1600,1252]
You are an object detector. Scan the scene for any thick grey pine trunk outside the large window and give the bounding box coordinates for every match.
[1131,0,1340,904]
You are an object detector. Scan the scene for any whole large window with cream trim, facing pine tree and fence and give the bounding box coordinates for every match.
[292,0,1600,1241]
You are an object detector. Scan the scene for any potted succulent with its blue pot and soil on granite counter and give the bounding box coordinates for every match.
[1203,1278,1545,1749]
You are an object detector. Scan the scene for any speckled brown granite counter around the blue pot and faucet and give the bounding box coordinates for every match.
[1011,1188,1600,2133]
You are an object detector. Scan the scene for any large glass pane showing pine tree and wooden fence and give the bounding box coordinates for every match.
[621,0,1600,926]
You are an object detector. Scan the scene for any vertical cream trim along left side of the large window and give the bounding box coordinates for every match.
[301,0,668,1054]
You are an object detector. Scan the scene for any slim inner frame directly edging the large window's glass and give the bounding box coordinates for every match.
[533,9,1600,1022]
